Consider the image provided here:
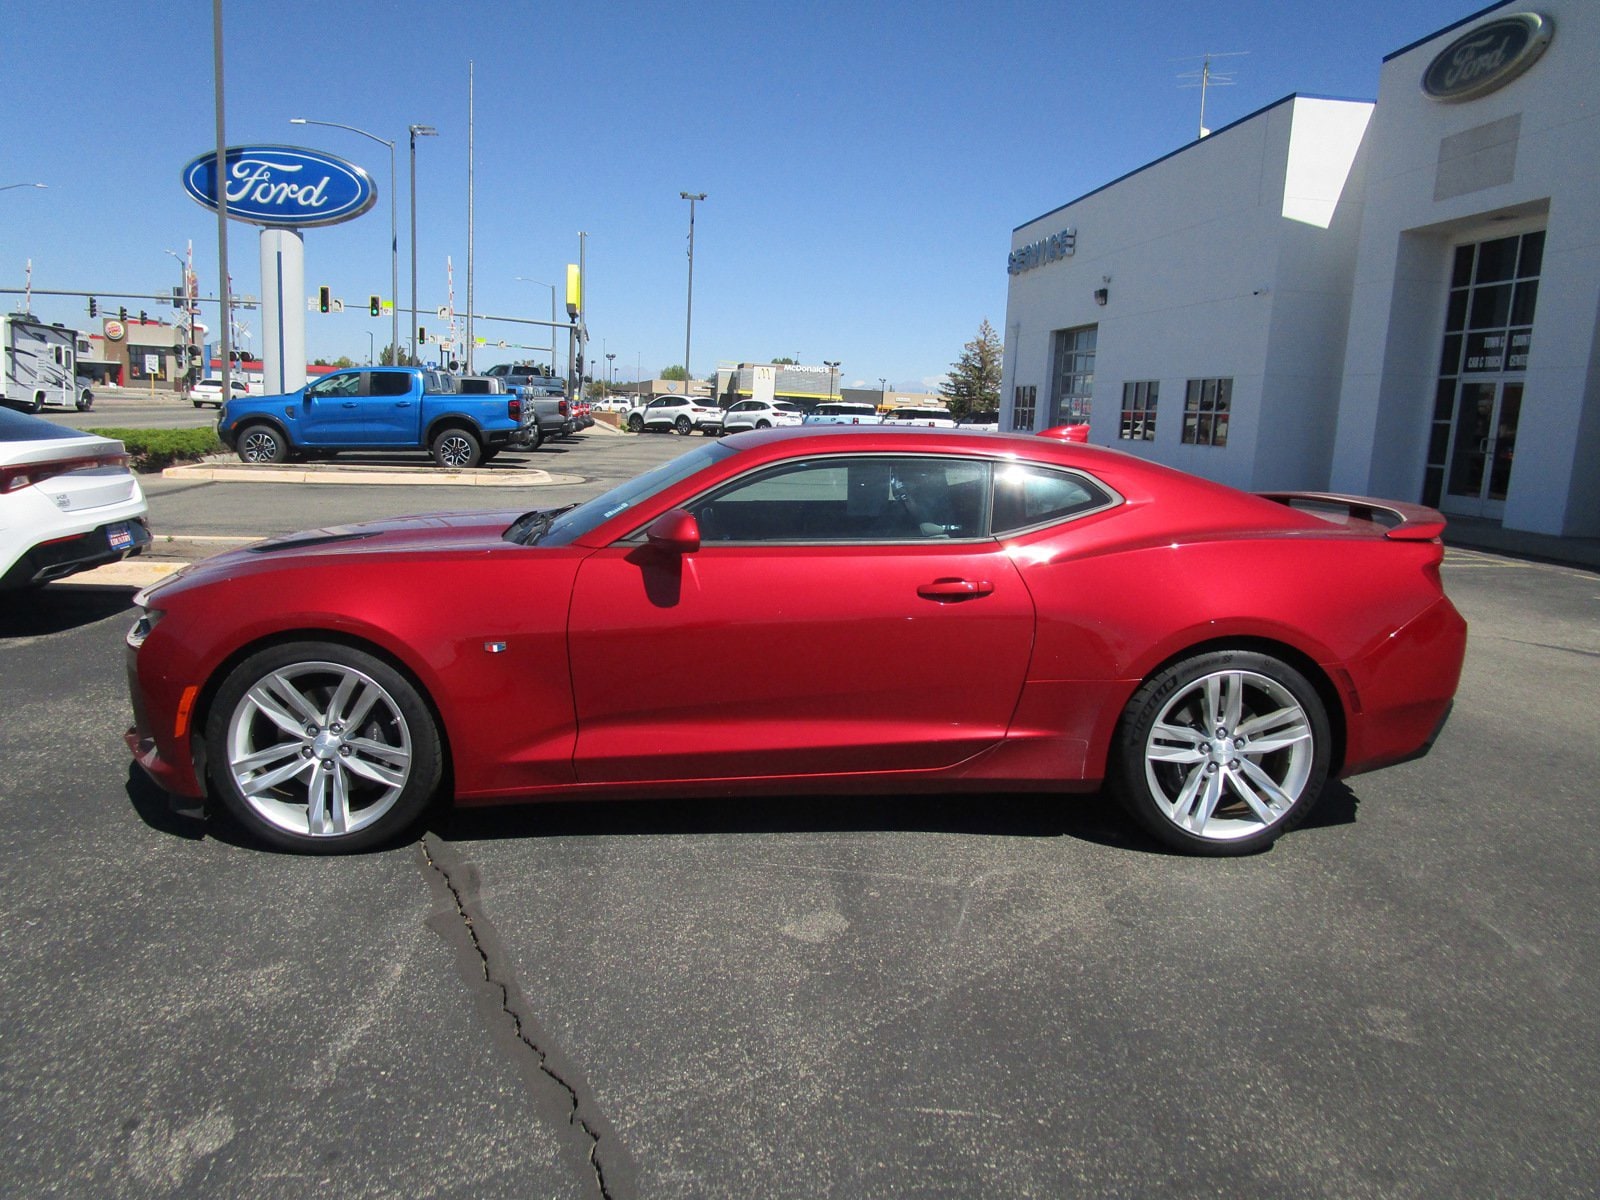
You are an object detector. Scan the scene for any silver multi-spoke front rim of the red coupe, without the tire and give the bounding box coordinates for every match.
[226,662,411,837]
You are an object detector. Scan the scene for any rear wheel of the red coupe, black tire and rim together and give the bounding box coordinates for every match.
[1109,650,1331,856]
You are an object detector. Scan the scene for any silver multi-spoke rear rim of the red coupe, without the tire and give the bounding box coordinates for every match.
[1144,670,1317,842]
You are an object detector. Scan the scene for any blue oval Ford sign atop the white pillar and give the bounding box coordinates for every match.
[182,146,378,229]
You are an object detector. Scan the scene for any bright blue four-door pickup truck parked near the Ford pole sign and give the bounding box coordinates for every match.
[216,366,538,470]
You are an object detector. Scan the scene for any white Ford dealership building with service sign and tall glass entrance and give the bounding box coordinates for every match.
[1002,0,1600,538]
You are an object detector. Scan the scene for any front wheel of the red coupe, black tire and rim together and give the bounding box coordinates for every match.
[205,642,443,854]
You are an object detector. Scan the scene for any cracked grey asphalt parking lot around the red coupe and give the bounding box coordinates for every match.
[0,437,1600,1197]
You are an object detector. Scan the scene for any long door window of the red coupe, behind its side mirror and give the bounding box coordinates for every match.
[690,456,989,542]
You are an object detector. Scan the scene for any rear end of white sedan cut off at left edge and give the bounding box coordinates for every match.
[0,408,150,592]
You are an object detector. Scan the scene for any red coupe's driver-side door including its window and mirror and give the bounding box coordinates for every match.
[568,456,1034,782]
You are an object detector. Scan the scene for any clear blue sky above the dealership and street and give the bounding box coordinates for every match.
[0,0,1485,390]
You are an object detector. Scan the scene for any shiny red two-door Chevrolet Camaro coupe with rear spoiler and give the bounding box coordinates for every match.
[128,427,1466,854]
